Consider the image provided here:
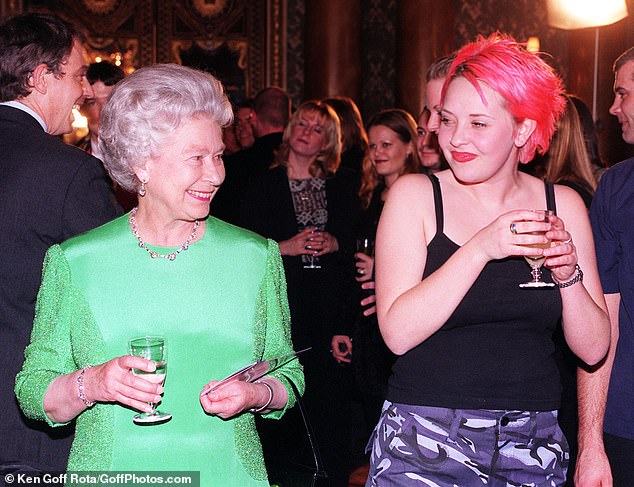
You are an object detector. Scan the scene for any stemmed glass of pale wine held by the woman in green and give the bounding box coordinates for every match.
[128,335,172,424]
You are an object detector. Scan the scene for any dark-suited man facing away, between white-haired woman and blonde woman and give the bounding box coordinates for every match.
[211,87,291,224]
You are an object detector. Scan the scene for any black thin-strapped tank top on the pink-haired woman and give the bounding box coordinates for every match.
[387,175,561,411]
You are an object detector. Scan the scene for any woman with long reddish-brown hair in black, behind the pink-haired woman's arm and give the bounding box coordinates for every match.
[348,109,423,476]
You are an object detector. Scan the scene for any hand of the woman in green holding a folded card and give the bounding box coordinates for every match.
[200,380,269,419]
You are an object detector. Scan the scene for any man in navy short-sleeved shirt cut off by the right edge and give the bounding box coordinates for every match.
[575,47,634,487]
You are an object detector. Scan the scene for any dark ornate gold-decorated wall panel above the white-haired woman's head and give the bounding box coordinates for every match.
[0,0,286,100]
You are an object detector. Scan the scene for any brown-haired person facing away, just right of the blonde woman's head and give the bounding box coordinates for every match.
[323,96,368,173]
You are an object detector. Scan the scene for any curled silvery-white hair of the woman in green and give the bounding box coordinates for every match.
[99,64,233,191]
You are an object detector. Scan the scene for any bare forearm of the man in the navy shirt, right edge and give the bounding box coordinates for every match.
[575,293,621,487]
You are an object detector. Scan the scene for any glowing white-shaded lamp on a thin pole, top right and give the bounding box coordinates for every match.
[547,0,627,121]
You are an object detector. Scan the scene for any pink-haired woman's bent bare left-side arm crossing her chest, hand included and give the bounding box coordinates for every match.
[376,176,547,354]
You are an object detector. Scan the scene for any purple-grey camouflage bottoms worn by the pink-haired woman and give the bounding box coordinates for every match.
[366,401,569,487]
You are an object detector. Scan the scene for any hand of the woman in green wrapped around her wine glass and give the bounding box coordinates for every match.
[84,355,163,412]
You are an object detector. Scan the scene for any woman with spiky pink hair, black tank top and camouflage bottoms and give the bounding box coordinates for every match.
[367,34,610,487]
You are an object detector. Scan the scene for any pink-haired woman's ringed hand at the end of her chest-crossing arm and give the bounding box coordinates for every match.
[469,210,551,262]
